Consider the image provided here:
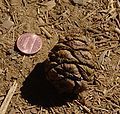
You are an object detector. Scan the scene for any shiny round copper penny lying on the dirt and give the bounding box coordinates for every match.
[17,33,42,54]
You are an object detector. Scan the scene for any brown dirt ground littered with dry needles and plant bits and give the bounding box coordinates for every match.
[0,0,120,114]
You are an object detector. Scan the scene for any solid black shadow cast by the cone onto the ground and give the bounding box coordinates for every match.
[21,63,79,107]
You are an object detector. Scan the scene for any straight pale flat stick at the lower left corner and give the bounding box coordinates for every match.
[0,80,17,114]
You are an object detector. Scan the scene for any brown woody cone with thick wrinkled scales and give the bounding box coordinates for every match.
[45,30,95,94]
